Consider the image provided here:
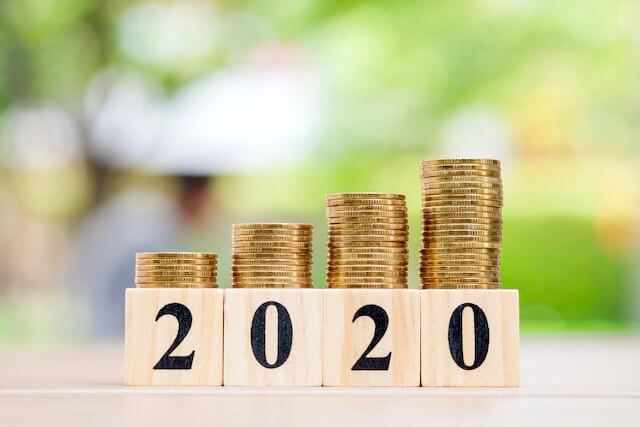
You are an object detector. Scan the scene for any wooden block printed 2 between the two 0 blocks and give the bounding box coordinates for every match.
[322,289,420,387]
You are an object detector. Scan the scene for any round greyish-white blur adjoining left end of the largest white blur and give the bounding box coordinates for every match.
[85,70,164,168]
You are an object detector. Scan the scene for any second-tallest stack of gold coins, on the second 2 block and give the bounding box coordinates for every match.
[326,193,409,288]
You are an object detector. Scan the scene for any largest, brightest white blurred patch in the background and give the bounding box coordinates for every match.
[148,61,319,173]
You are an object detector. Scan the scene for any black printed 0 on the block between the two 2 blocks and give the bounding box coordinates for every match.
[251,301,293,369]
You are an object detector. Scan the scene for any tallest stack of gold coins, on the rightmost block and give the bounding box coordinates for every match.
[420,159,502,289]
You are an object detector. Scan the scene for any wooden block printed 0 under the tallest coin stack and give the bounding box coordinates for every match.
[421,289,520,387]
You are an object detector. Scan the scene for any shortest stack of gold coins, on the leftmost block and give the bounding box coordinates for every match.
[135,252,218,288]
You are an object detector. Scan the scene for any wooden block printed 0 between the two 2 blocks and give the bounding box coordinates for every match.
[224,289,323,386]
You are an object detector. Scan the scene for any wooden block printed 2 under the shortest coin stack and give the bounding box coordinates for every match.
[124,289,224,386]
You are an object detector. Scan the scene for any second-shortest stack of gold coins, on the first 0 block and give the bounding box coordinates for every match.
[232,224,313,288]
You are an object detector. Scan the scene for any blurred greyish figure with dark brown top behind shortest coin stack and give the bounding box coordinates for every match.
[70,174,210,338]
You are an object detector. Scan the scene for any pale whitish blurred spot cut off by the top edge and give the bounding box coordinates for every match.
[118,1,216,68]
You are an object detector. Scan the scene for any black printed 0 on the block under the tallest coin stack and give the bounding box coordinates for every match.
[449,303,489,371]
